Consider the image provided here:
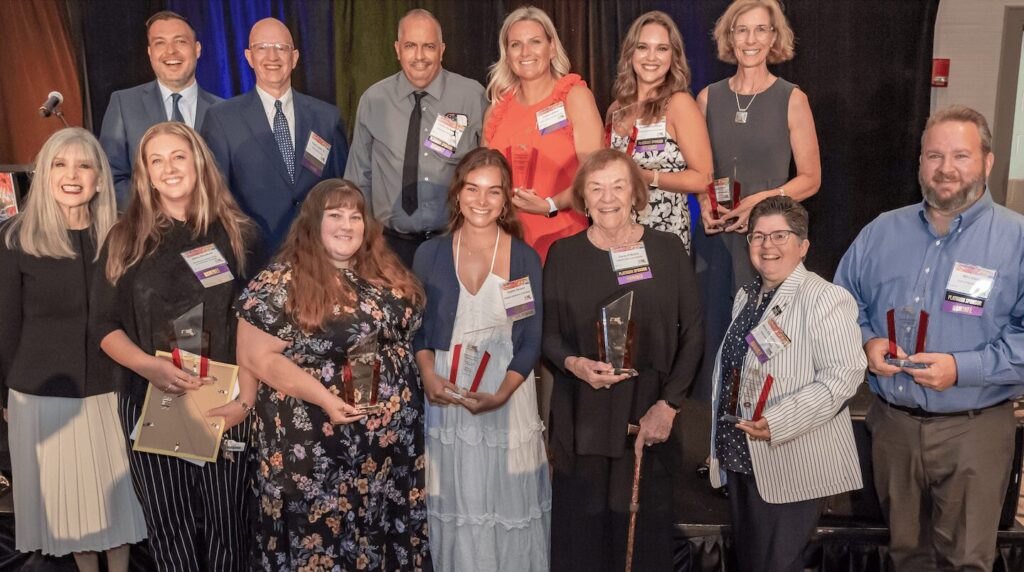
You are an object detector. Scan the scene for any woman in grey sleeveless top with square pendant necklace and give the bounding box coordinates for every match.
[693,0,821,482]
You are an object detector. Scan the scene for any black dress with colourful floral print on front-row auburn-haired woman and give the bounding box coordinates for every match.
[239,263,431,571]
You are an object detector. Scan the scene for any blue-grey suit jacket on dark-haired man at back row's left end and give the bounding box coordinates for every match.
[99,80,223,210]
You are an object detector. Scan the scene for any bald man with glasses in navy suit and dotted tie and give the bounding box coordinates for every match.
[202,18,348,257]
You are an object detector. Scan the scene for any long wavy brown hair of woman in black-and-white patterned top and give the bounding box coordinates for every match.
[608,10,690,123]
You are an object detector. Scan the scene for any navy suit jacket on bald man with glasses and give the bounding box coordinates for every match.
[201,89,348,263]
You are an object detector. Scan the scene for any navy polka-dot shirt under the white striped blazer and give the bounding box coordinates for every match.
[715,276,777,475]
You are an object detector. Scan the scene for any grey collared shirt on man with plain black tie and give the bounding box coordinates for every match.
[345,70,487,232]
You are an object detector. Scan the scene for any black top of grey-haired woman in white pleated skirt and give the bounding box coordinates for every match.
[0,222,117,407]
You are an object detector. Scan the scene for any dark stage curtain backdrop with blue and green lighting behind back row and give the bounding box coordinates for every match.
[79,0,938,278]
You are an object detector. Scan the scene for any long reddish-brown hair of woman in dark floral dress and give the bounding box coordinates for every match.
[274,179,426,332]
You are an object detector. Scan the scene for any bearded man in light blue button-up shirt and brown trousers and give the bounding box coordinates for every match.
[836,105,1024,571]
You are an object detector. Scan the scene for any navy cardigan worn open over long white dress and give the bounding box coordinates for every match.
[413,234,544,378]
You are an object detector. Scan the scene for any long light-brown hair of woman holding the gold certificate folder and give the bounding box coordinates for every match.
[106,122,255,284]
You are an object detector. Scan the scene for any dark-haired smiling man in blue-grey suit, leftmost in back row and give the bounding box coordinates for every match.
[99,10,221,210]
